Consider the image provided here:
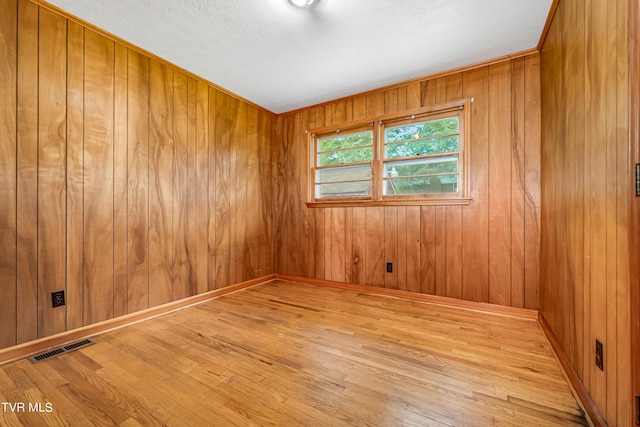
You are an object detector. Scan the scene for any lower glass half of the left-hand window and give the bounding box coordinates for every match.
[316,165,371,198]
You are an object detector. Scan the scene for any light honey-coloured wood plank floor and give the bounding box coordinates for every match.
[0,281,586,426]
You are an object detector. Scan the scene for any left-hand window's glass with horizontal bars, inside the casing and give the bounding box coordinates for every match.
[314,129,374,199]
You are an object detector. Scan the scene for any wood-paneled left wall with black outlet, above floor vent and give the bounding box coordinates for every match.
[0,0,275,348]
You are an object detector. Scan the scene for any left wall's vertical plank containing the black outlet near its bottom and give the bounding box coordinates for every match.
[37,8,67,337]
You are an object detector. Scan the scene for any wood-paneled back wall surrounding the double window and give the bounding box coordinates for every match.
[275,54,540,309]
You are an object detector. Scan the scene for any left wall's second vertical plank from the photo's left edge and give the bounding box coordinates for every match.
[15,0,38,344]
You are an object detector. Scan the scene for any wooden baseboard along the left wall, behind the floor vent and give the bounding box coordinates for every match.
[0,274,276,365]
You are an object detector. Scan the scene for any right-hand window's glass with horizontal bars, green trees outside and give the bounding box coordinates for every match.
[381,111,461,197]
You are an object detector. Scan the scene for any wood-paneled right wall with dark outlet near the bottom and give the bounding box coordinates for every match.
[540,0,635,426]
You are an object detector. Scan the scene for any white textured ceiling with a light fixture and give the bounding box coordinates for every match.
[43,0,552,113]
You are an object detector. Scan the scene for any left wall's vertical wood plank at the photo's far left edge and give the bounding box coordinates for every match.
[0,0,18,347]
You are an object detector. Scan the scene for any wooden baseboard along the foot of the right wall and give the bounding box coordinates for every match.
[538,313,607,427]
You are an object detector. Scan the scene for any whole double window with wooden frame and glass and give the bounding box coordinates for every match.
[308,101,471,206]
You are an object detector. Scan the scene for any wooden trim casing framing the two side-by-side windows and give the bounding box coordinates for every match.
[306,98,473,208]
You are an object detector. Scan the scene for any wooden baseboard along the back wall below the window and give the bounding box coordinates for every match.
[276,274,538,320]
